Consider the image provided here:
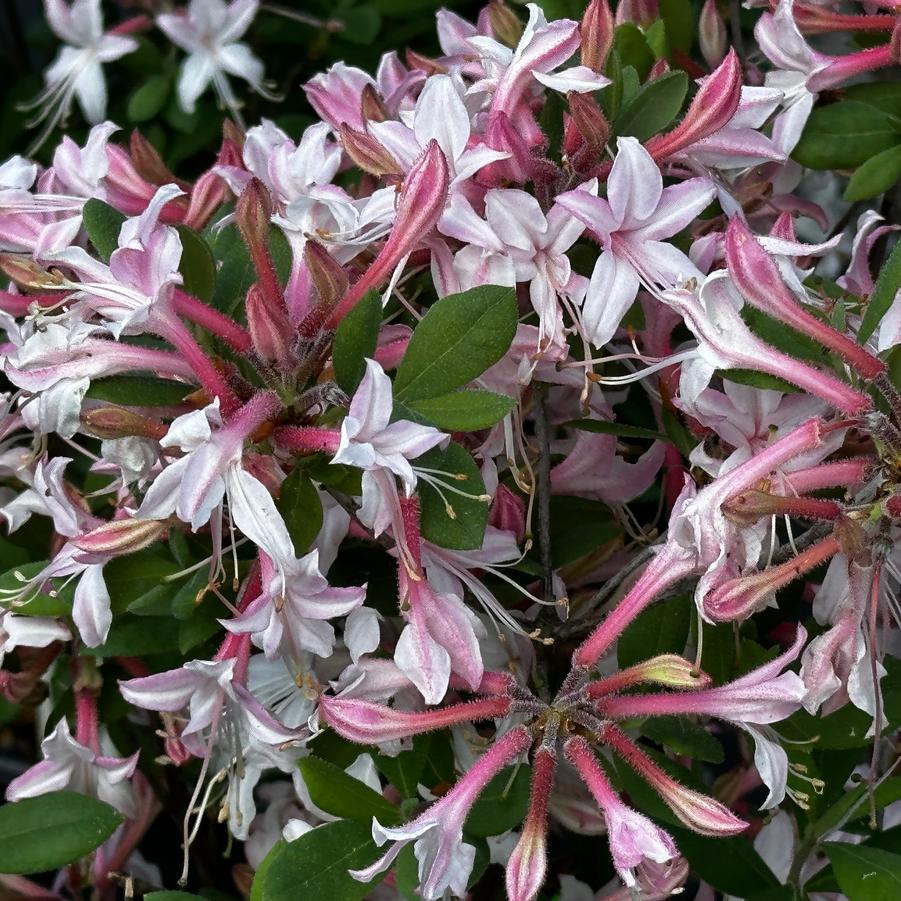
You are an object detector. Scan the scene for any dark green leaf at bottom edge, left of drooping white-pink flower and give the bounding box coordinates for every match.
[260,820,381,901]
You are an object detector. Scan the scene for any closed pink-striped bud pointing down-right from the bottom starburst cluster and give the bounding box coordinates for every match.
[598,723,748,836]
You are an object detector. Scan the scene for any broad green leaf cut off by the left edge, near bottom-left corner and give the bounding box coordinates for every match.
[0,791,123,874]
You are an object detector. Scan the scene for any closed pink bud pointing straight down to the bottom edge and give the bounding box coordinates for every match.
[506,747,557,901]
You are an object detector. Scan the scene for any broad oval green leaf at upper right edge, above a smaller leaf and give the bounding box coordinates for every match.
[792,100,901,169]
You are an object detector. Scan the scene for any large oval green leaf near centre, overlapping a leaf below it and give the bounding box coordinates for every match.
[394,285,517,403]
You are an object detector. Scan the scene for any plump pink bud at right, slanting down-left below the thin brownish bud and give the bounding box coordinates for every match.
[703,536,841,623]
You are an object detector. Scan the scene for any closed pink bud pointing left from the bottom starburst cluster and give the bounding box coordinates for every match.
[319,695,510,745]
